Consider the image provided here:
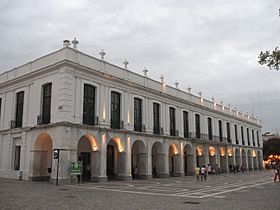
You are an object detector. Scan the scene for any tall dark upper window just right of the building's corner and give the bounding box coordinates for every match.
[83,84,95,125]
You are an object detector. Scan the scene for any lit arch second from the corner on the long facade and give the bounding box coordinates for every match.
[106,137,126,180]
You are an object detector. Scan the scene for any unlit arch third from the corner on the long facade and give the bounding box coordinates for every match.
[131,140,148,178]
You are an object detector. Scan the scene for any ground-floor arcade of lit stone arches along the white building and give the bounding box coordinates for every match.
[29,130,263,183]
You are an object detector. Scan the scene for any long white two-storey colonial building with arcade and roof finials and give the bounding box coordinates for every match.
[0,40,263,183]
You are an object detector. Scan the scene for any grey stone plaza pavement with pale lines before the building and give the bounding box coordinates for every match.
[0,170,280,210]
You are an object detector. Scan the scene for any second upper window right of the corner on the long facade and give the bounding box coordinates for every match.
[111,91,121,129]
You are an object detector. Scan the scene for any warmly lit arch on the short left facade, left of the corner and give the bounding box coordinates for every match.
[32,132,53,181]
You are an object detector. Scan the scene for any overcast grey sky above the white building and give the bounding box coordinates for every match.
[0,0,280,132]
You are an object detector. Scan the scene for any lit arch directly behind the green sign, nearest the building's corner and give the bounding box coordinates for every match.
[77,134,100,181]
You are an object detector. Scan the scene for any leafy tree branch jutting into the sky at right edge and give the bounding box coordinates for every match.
[258,47,280,71]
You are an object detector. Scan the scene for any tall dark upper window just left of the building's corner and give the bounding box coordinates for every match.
[42,83,52,124]
